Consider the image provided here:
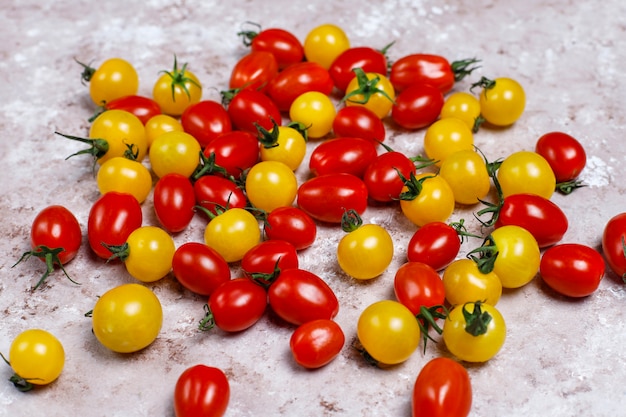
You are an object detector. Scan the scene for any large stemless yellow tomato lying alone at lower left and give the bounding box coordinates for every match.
[91,284,163,353]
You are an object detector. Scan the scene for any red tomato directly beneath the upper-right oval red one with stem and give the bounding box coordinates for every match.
[391,83,444,130]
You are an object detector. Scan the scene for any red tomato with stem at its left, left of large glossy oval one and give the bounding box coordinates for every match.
[208,277,267,332]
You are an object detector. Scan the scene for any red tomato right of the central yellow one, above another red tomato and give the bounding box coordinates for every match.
[264,206,317,251]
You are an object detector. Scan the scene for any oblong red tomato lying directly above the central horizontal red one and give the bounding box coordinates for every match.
[309,137,378,178]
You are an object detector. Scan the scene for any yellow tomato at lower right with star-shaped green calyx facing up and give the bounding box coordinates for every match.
[442,301,506,362]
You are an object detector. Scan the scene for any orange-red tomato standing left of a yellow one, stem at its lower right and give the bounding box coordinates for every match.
[393,261,446,315]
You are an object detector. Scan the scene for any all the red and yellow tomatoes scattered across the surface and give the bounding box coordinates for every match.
[2,24,626,416]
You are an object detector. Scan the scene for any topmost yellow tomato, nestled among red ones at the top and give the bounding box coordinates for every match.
[303,24,350,69]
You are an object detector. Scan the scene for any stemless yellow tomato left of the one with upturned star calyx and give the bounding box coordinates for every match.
[357,300,420,365]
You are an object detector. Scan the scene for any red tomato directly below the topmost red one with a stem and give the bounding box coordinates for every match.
[228,51,278,91]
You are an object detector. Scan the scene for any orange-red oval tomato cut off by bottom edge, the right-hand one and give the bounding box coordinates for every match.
[411,357,472,417]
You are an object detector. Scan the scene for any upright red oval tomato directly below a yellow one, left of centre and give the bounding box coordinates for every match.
[152,173,196,233]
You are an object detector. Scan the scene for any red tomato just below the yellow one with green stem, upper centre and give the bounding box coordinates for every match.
[333,106,386,145]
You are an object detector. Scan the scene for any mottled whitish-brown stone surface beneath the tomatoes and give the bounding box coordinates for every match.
[0,0,626,417]
